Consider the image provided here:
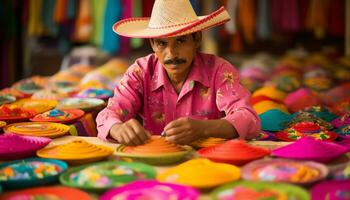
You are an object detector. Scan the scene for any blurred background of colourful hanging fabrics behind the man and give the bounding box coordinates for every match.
[0,0,350,89]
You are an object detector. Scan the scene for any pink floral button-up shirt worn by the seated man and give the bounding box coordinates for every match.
[96,53,260,139]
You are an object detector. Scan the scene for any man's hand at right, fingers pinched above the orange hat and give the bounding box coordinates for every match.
[164,117,206,144]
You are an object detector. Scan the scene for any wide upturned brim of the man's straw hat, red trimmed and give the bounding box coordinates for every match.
[113,7,230,38]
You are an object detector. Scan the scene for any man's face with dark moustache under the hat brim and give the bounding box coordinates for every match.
[150,32,201,76]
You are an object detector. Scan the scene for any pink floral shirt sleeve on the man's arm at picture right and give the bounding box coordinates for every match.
[215,62,260,139]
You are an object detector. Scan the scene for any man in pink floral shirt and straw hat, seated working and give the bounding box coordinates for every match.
[97,0,260,145]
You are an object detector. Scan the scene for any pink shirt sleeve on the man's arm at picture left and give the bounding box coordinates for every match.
[96,62,143,140]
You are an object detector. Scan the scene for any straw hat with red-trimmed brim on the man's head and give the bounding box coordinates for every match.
[113,0,230,38]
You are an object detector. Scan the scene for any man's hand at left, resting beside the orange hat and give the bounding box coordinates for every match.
[109,119,151,145]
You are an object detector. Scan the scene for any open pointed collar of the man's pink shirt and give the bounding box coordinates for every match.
[151,53,210,91]
